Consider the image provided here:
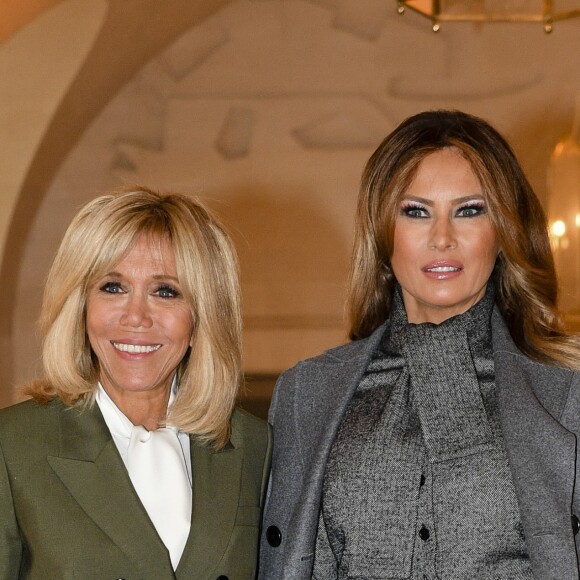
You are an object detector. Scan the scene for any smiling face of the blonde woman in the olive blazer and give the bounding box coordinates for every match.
[87,236,193,402]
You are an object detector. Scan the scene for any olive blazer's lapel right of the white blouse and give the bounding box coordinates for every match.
[176,437,243,579]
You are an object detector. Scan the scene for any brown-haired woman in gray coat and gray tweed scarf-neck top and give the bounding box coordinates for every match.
[260,111,580,580]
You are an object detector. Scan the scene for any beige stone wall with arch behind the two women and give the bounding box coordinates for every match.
[0,0,580,405]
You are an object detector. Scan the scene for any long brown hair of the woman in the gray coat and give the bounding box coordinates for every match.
[348,111,580,369]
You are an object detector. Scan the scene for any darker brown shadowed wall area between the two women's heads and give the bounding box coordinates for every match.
[208,185,356,374]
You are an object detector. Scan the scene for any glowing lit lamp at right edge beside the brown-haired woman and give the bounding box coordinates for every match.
[548,93,580,326]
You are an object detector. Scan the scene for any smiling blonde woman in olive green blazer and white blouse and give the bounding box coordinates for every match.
[0,188,269,580]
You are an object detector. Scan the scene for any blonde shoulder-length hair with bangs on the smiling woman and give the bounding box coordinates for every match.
[28,187,242,448]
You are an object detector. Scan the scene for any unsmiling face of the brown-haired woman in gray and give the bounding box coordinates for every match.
[391,148,499,324]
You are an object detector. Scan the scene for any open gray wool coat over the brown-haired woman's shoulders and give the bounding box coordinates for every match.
[258,308,580,580]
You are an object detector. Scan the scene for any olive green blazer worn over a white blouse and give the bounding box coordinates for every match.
[0,400,270,580]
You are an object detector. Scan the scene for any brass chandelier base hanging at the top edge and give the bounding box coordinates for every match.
[397,0,580,32]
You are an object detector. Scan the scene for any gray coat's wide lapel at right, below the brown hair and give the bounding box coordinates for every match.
[492,312,578,580]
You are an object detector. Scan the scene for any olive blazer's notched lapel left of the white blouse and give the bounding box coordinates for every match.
[48,405,174,580]
